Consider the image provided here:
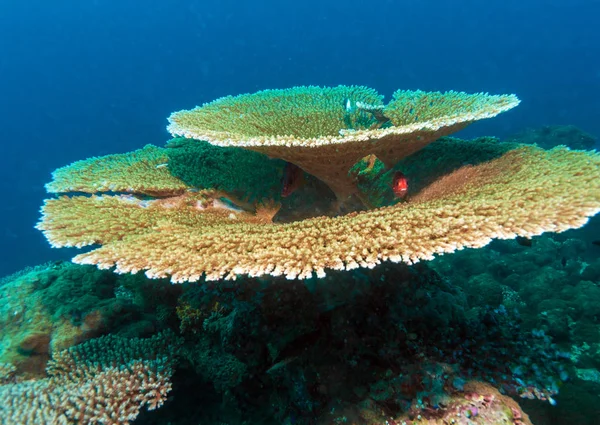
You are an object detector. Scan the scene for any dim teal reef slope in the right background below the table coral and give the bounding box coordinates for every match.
[431,218,600,425]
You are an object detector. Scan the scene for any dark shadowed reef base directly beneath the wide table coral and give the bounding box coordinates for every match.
[136,265,563,424]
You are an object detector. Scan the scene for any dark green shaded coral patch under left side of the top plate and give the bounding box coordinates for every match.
[166,138,285,201]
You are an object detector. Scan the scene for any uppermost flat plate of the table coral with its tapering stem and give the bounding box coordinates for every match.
[168,86,519,201]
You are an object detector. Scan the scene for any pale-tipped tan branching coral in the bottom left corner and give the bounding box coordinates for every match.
[0,334,176,425]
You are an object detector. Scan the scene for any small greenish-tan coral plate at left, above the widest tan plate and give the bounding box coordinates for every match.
[46,145,187,196]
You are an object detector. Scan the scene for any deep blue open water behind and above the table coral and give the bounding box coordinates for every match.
[0,0,600,275]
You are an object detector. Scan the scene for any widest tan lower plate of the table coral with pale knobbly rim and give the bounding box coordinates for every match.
[38,142,600,282]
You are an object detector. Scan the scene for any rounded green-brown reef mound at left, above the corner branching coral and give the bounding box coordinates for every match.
[0,263,180,377]
